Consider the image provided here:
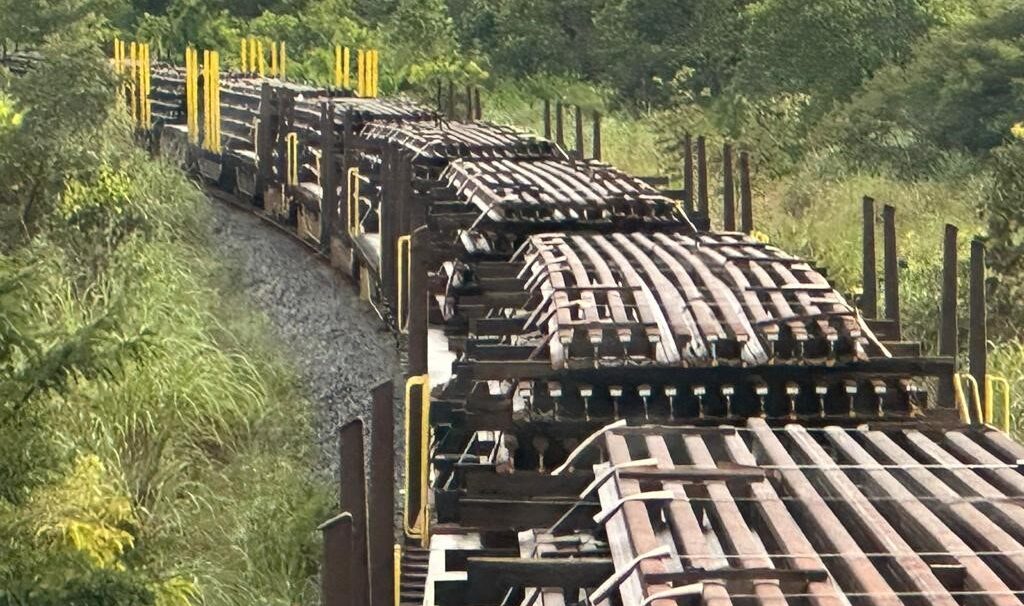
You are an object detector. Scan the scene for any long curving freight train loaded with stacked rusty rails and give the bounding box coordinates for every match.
[9,46,1024,606]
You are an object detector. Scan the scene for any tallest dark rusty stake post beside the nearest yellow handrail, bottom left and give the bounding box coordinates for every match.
[367,381,394,606]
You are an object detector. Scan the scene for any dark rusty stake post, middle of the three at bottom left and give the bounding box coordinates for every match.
[338,419,370,604]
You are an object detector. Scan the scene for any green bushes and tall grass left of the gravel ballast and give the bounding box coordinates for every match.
[0,24,328,606]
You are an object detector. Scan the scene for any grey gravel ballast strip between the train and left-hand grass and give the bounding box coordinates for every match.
[205,201,401,478]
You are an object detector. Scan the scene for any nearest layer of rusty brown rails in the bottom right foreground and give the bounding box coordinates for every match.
[432,419,1024,606]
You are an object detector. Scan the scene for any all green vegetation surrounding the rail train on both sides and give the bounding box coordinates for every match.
[0,0,1024,605]
